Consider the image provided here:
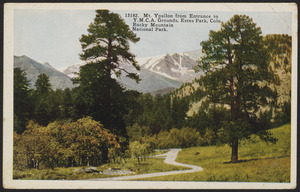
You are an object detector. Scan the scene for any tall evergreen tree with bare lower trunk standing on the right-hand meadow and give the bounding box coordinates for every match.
[198,15,276,162]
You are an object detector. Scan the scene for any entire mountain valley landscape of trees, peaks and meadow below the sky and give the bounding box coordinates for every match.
[12,9,294,183]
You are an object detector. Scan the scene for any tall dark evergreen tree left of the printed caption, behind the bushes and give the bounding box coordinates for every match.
[77,10,140,136]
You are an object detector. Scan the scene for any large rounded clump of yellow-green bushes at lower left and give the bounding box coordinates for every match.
[14,117,120,169]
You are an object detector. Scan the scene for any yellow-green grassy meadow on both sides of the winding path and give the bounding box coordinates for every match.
[13,124,291,182]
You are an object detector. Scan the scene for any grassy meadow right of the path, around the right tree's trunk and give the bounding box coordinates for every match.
[141,125,291,182]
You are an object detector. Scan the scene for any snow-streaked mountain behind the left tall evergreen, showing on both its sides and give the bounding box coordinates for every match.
[60,50,202,93]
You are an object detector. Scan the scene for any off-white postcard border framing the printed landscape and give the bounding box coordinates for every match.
[3,3,298,189]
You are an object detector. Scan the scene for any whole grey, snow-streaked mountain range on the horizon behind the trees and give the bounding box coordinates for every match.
[14,50,202,95]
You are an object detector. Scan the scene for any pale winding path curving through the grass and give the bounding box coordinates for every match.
[89,149,203,181]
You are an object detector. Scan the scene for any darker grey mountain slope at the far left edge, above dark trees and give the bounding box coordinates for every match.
[14,55,75,90]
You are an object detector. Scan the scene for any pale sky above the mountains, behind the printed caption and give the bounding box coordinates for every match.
[14,9,292,69]
